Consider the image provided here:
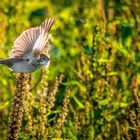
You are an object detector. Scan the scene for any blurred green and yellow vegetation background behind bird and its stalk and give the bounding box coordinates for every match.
[0,0,140,140]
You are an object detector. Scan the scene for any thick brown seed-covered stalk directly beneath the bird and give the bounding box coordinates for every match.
[7,73,29,140]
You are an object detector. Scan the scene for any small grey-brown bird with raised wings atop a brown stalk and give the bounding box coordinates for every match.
[0,18,56,73]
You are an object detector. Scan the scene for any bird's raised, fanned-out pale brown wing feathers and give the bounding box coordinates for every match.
[10,18,55,59]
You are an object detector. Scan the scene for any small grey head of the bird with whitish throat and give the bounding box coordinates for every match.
[38,54,50,67]
